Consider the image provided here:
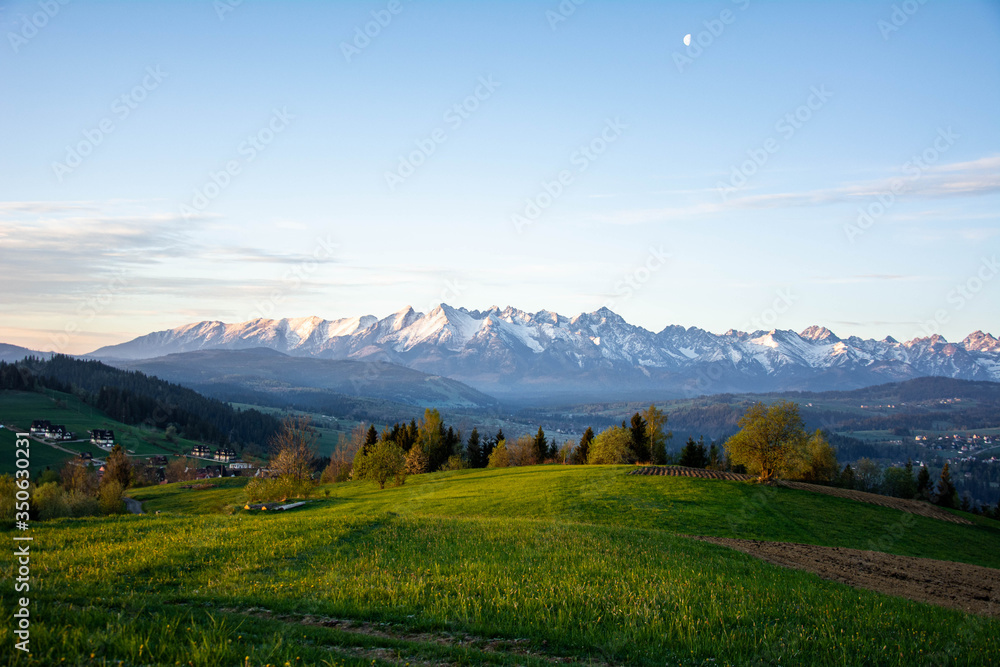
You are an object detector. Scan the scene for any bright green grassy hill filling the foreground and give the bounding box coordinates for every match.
[0,466,1000,666]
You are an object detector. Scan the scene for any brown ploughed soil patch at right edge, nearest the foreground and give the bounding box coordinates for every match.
[695,537,1000,618]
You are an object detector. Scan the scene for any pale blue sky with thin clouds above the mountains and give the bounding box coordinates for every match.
[0,0,1000,353]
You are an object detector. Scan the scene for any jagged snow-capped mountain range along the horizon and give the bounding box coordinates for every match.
[87,304,1000,400]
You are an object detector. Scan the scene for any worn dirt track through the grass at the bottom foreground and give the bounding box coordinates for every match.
[220,607,609,667]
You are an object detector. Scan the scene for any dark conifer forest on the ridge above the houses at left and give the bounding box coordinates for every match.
[0,355,281,448]
